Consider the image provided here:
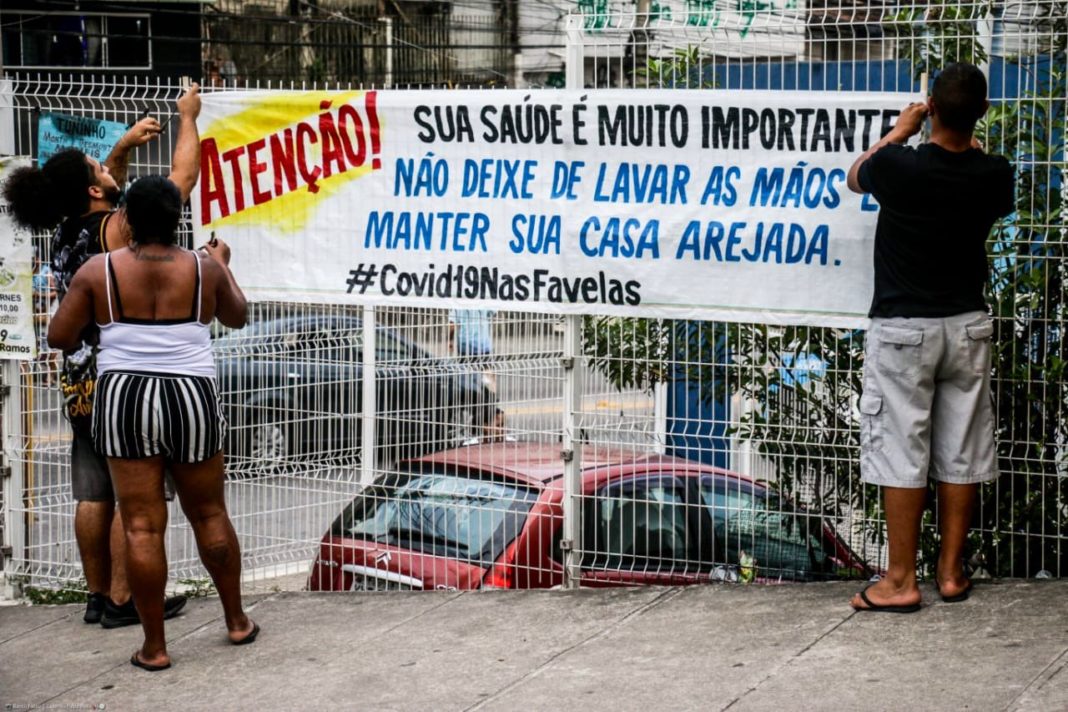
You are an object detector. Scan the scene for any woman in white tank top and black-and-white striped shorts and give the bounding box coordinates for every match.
[48,176,260,670]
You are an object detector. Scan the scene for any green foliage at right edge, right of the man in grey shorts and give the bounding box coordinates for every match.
[978,57,1068,575]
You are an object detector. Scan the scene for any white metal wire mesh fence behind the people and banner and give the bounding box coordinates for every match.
[3,0,1068,590]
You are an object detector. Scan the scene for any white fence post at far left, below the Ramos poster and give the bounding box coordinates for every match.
[0,361,26,599]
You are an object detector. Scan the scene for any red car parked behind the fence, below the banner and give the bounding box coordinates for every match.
[309,442,873,590]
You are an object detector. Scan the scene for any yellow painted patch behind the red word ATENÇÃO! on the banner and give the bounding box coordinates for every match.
[201,92,382,233]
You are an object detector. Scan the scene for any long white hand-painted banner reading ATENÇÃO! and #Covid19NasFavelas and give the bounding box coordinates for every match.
[193,90,910,327]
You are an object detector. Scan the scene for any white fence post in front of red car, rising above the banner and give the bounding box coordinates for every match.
[562,26,584,588]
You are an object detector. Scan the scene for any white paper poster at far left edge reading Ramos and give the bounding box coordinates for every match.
[0,156,36,361]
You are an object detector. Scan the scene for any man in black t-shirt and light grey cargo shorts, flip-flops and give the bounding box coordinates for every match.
[848,64,1014,613]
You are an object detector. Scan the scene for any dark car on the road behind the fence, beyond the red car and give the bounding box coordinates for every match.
[214,313,497,471]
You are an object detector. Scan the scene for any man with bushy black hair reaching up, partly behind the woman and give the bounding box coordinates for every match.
[3,84,200,628]
